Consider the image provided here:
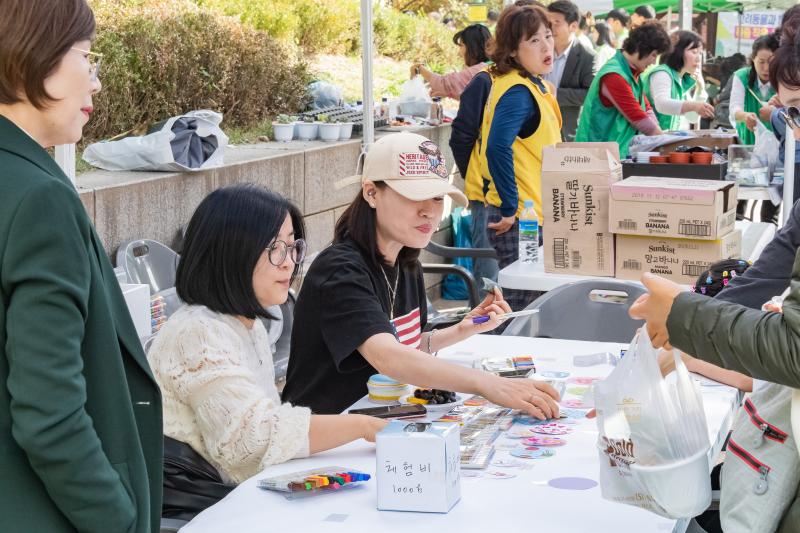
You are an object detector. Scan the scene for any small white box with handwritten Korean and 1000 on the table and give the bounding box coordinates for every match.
[375,420,461,513]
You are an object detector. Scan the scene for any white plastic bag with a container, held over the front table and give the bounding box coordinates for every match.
[594,328,711,518]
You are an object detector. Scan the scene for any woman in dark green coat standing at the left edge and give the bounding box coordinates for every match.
[0,0,163,533]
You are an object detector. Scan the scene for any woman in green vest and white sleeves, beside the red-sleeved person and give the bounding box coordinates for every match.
[644,31,714,131]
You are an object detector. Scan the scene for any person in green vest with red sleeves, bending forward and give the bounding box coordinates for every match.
[575,22,670,158]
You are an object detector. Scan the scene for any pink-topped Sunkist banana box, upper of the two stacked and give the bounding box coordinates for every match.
[609,176,739,240]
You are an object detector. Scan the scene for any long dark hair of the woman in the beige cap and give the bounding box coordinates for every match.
[333,181,419,271]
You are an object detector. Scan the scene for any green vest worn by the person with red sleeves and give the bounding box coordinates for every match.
[575,51,645,158]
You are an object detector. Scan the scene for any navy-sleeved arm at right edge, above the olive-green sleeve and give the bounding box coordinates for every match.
[715,197,800,309]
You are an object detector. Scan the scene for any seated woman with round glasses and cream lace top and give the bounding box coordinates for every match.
[148,185,385,511]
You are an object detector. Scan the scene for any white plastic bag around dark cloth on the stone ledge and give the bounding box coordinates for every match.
[83,110,228,172]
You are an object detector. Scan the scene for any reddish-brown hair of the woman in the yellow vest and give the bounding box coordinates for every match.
[489,5,550,76]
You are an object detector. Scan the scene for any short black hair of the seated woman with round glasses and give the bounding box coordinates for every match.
[175,184,305,319]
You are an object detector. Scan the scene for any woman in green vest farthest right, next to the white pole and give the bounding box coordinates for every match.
[730,34,778,144]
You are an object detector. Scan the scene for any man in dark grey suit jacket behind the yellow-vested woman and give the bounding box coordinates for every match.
[545,0,595,141]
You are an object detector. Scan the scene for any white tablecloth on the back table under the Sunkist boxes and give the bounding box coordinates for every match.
[497,220,776,291]
